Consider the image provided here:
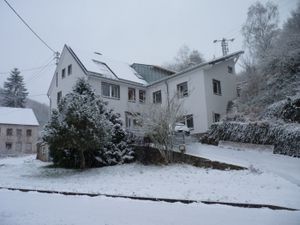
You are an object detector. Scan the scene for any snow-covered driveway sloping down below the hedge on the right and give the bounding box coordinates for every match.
[187,143,300,186]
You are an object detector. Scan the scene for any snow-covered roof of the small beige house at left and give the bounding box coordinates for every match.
[0,107,39,126]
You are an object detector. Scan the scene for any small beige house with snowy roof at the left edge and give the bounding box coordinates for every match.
[0,107,39,156]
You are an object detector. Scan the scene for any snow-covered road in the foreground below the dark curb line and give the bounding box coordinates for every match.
[0,190,300,225]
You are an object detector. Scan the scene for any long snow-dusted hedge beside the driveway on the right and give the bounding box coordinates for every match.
[201,121,300,157]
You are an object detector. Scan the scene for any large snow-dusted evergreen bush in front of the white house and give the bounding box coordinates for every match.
[43,79,133,169]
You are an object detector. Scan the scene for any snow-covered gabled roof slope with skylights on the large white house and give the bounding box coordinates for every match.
[68,46,148,85]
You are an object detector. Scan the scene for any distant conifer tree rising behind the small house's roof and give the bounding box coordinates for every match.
[3,68,28,108]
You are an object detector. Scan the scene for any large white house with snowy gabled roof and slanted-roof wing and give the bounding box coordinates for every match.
[48,45,243,133]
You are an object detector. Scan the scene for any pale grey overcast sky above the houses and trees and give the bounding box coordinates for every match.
[0,0,297,104]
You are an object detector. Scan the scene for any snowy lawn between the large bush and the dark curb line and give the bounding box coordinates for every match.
[0,150,300,209]
